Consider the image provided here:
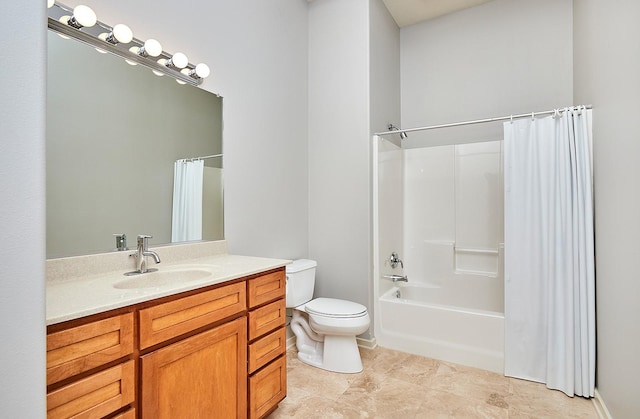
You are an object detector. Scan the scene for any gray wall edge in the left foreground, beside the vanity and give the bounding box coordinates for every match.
[0,2,46,418]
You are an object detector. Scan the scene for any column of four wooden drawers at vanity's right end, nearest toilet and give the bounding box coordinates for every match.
[247,268,287,418]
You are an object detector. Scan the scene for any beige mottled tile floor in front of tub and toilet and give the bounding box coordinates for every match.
[268,347,598,419]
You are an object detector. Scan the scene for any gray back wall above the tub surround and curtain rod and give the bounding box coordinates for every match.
[401,0,573,130]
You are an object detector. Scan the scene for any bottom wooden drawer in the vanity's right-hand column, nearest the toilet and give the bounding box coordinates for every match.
[249,355,287,418]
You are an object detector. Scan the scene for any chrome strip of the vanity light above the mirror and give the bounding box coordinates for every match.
[48,1,209,86]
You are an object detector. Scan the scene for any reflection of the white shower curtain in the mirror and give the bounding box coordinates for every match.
[171,160,204,242]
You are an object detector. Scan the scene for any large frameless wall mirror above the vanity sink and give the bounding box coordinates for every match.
[46,31,224,259]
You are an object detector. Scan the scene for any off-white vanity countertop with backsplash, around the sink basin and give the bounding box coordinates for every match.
[46,240,290,325]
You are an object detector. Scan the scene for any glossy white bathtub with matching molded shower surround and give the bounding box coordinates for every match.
[373,137,504,373]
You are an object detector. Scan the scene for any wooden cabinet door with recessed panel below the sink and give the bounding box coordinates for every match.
[141,317,247,419]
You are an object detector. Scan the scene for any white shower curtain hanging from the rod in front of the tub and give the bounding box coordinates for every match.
[504,109,595,397]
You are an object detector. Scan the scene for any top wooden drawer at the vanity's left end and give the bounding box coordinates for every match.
[47,313,133,385]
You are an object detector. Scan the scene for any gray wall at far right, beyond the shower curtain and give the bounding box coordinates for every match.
[574,0,640,419]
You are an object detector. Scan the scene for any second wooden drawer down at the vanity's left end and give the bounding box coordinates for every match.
[47,361,135,419]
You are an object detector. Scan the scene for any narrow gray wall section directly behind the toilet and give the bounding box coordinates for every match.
[308,0,371,318]
